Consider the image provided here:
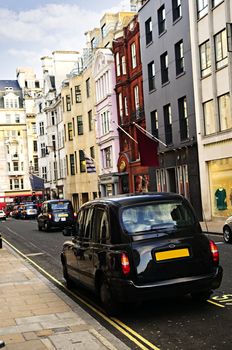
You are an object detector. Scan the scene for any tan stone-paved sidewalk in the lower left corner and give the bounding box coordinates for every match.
[0,243,129,350]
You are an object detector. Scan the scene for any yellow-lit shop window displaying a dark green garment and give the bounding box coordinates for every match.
[209,158,232,217]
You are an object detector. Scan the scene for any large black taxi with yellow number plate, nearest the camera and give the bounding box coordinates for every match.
[61,193,222,314]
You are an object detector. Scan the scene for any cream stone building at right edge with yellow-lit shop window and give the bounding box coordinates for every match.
[189,0,232,220]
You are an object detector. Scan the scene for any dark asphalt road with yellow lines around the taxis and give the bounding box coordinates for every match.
[0,219,232,350]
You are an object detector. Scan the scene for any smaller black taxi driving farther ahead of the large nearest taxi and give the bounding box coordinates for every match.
[37,199,76,231]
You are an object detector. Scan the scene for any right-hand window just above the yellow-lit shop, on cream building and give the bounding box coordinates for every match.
[218,93,232,130]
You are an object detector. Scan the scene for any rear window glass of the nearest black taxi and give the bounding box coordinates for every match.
[122,201,195,233]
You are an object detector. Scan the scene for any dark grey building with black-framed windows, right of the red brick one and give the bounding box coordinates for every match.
[139,0,202,218]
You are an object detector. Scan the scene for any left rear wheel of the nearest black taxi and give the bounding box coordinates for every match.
[100,279,119,316]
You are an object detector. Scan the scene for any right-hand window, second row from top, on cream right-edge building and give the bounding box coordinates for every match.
[214,29,228,69]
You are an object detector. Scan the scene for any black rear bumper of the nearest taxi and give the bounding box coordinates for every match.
[110,266,223,302]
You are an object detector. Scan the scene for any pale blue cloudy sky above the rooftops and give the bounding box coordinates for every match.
[0,0,130,80]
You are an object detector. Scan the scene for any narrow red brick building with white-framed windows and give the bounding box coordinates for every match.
[113,16,149,193]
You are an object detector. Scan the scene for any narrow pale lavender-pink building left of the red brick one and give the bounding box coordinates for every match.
[93,48,119,196]
